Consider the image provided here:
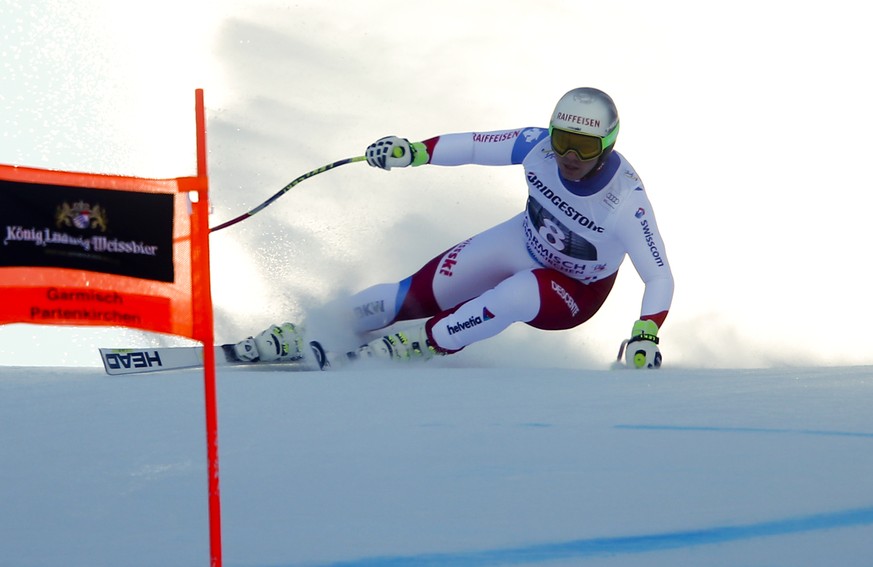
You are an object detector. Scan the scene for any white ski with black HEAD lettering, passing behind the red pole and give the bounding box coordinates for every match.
[99,344,321,376]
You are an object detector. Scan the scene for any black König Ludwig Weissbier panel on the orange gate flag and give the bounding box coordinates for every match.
[0,180,174,282]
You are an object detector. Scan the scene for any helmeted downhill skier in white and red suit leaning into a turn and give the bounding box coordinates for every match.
[235,88,673,368]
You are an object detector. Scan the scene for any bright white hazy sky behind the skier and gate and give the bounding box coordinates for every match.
[0,0,873,366]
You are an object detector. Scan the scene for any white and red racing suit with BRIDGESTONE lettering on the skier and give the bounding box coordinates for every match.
[343,128,673,353]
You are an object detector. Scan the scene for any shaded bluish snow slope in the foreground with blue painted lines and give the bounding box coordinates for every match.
[0,362,873,567]
